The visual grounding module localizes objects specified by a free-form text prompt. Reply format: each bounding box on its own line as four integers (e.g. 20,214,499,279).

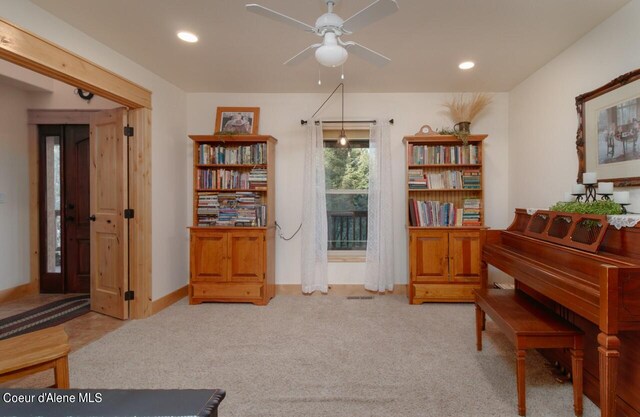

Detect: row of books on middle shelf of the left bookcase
197,168,267,190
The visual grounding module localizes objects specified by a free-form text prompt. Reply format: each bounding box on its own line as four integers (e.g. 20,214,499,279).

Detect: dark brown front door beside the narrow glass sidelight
62,125,91,293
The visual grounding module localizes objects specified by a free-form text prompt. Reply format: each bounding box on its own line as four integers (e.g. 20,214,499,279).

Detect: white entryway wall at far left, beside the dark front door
0,83,29,291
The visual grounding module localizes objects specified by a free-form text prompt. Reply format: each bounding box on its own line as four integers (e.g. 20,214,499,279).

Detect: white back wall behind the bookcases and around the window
182,92,511,284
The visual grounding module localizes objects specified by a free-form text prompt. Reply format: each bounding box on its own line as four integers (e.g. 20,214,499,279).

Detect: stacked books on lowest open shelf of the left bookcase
196,191,267,227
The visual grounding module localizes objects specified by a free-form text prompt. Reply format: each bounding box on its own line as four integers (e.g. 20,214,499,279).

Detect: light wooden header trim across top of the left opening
0,19,151,109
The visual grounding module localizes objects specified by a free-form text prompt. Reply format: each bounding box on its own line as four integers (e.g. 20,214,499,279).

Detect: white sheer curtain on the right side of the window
364,120,395,292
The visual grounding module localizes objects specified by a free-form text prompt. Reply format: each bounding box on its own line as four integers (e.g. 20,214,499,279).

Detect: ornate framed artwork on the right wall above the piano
576,69,640,187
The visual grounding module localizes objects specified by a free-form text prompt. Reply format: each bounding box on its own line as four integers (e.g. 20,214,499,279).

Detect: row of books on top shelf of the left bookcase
198,143,267,165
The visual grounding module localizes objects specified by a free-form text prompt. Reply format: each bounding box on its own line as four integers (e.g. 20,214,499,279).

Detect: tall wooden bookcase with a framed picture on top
189,135,277,305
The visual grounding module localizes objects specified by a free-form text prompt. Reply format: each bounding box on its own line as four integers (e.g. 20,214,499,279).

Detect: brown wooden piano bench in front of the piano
474,289,583,416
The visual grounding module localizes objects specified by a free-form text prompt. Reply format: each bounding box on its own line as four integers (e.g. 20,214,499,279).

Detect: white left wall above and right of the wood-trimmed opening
0,0,189,299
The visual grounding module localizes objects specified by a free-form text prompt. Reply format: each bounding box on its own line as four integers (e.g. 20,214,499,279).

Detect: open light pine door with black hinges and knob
90,108,129,319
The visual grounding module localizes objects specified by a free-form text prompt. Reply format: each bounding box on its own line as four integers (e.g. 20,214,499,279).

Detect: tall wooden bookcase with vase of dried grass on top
403,135,487,304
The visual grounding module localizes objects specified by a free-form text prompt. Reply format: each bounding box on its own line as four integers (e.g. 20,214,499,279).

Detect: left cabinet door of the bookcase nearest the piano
409,230,449,282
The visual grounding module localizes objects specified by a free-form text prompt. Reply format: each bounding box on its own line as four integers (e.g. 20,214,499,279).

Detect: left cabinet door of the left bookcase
190,230,228,282
